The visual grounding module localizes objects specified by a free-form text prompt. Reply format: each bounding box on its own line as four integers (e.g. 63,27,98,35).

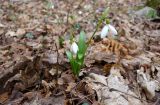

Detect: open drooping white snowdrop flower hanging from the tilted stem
101,24,118,38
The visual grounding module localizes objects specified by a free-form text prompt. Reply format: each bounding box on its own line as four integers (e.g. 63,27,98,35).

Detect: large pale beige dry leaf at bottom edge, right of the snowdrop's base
86,67,143,105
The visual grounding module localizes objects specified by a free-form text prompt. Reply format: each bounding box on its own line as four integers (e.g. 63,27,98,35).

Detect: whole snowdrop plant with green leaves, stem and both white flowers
66,8,118,77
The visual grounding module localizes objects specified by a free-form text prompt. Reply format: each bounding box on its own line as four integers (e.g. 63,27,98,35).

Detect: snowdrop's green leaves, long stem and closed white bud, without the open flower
66,8,109,77
